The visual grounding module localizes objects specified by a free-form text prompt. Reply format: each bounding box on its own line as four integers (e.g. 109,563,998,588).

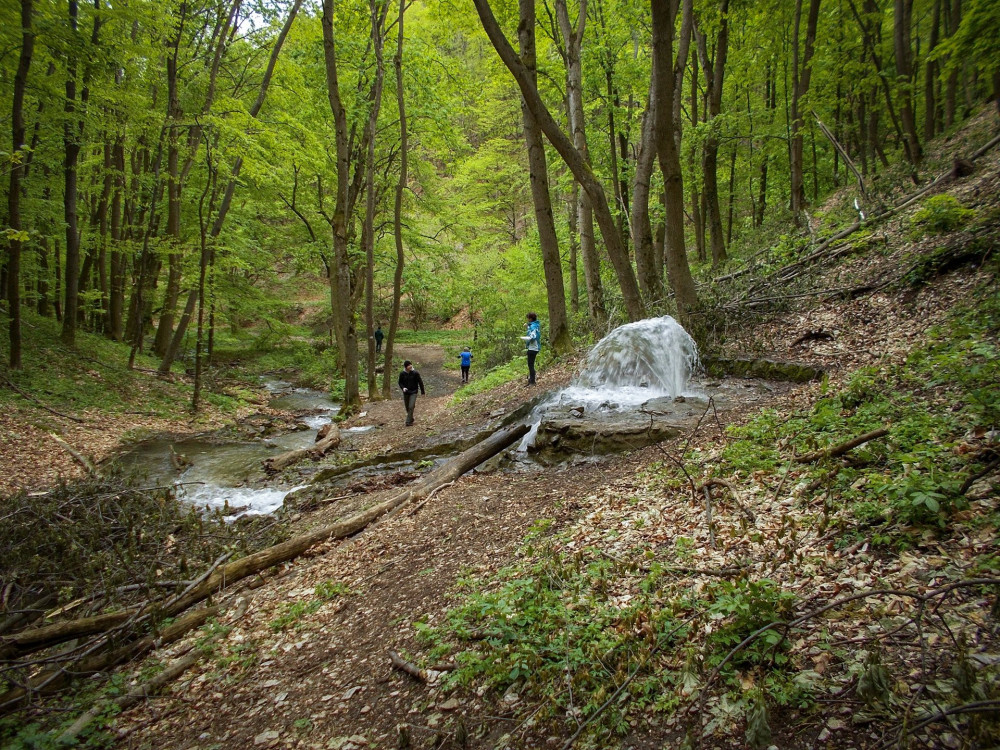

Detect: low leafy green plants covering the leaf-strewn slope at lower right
417,268,1000,747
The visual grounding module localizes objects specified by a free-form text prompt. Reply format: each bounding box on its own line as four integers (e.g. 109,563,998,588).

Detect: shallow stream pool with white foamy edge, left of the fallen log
119,380,340,517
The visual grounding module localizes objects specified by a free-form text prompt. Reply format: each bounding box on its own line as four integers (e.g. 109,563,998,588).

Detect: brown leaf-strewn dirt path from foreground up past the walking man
119,345,584,749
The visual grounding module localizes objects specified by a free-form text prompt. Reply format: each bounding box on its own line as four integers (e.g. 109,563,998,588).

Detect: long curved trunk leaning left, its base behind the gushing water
475,0,644,320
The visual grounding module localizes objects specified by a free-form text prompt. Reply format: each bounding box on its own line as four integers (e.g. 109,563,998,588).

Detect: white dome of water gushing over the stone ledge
518,315,699,451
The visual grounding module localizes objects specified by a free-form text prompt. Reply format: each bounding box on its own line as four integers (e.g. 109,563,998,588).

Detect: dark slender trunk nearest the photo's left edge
7,0,35,370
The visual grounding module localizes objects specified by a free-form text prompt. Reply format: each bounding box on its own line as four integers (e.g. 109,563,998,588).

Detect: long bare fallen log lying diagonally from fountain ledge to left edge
0,424,528,680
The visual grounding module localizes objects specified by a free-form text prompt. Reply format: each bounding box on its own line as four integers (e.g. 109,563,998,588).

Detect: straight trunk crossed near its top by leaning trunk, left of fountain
518,0,573,355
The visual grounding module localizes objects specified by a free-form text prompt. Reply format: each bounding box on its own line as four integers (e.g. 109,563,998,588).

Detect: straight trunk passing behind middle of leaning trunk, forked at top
556,0,608,332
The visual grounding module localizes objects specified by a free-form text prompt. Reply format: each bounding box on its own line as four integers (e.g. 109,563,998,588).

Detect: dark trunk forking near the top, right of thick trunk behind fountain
698,0,729,268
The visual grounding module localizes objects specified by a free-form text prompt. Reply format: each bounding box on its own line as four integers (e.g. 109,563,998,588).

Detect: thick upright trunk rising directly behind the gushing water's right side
652,0,698,323
